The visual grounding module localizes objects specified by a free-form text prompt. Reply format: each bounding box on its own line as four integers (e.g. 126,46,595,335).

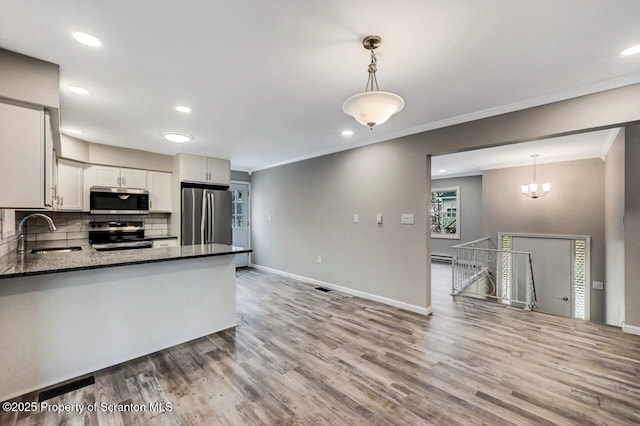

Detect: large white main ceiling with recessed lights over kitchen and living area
0,0,640,170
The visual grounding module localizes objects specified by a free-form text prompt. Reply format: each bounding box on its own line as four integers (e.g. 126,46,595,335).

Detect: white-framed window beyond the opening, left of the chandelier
431,187,460,240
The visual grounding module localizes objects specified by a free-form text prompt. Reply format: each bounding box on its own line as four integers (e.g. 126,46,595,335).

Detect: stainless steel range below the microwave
89,221,153,251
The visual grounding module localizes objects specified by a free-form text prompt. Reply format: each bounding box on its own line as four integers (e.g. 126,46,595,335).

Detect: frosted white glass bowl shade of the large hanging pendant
342,90,404,128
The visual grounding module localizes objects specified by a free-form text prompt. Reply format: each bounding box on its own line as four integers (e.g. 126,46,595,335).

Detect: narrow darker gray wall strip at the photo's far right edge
624,123,640,333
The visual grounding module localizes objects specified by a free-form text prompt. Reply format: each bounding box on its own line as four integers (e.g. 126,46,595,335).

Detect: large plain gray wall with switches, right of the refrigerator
251,143,428,308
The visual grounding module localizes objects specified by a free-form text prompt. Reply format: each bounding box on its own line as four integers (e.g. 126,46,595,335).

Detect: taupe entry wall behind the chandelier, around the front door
482,158,604,322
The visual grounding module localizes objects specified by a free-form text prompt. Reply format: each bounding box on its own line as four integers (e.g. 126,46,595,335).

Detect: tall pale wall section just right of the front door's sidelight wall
604,129,625,326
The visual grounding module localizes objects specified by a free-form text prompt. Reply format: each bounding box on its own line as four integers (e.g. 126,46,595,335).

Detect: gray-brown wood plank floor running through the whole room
0,263,640,425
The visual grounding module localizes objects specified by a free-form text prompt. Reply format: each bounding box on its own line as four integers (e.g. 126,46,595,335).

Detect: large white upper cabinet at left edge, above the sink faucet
0,103,53,209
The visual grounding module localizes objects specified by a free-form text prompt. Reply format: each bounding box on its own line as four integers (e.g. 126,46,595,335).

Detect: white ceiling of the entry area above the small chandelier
431,129,620,179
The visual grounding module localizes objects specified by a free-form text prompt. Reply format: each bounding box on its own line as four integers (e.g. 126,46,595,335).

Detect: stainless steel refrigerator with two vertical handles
182,187,232,246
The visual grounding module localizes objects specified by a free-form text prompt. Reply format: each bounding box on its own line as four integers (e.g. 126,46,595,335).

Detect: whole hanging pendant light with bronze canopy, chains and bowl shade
342,36,404,129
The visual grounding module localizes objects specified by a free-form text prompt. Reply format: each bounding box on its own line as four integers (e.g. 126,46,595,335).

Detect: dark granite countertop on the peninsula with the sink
0,240,253,279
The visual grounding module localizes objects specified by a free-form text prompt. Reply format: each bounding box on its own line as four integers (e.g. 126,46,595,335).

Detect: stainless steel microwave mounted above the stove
89,186,149,214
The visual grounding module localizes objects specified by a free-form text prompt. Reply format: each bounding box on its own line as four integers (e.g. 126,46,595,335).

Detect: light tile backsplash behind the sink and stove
14,211,169,245
